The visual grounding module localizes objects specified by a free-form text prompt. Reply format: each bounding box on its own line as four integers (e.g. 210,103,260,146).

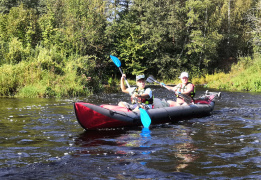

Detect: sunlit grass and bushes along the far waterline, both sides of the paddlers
0,47,261,97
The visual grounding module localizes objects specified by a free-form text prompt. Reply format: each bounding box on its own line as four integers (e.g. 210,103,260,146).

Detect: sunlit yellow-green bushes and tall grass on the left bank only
0,46,102,97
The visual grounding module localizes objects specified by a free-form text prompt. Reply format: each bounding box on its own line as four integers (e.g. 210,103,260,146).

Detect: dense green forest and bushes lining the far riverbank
0,0,261,97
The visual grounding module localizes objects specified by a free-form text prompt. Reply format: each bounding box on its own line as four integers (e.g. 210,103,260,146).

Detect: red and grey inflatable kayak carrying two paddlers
74,92,220,130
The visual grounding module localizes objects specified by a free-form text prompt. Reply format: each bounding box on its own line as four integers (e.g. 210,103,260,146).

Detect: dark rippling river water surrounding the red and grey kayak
0,87,261,180
